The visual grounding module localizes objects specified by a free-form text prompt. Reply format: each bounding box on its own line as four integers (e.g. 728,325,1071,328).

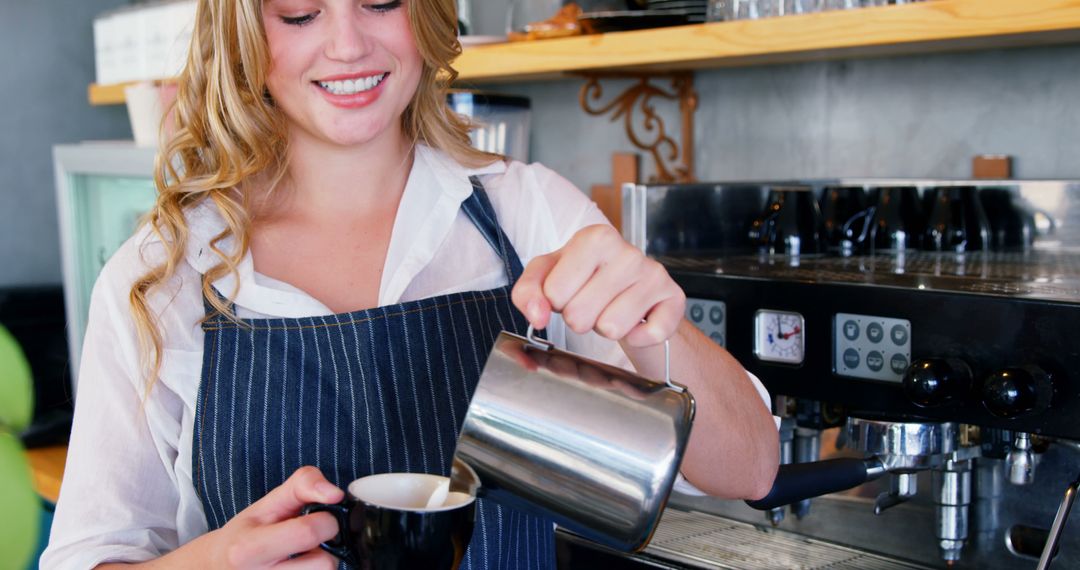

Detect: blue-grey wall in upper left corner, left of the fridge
0,0,131,286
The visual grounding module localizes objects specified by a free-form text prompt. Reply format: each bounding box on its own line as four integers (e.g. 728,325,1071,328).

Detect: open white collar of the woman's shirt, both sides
185,145,507,317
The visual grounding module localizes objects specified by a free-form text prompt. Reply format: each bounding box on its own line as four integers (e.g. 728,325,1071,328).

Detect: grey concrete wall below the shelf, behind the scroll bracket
483,42,1080,190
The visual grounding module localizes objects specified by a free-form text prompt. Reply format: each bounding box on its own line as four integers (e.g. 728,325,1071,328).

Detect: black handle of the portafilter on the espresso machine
746,457,887,511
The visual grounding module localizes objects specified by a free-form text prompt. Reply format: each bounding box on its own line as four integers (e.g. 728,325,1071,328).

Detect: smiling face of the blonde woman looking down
262,0,423,146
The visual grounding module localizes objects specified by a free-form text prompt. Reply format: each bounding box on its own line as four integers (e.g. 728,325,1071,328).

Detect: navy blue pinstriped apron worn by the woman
192,177,555,570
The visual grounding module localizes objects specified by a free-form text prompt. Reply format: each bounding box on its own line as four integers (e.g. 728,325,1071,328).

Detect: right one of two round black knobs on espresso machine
983,366,1054,419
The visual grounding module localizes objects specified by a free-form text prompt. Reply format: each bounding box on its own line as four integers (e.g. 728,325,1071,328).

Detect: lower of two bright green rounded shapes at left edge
0,432,41,569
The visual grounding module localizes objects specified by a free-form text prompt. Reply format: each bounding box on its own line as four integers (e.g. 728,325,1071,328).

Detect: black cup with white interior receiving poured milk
302,473,476,570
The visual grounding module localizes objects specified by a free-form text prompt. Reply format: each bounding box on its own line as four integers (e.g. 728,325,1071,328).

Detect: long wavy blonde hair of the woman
129,0,501,393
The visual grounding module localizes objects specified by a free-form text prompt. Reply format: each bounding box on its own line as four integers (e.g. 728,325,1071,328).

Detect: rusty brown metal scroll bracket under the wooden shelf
580,71,698,184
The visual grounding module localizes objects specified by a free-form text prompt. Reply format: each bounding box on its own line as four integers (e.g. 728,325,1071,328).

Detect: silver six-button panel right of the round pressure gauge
833,313,912,383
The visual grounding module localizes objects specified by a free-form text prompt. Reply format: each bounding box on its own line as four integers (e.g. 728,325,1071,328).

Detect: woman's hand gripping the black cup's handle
98,466,345,570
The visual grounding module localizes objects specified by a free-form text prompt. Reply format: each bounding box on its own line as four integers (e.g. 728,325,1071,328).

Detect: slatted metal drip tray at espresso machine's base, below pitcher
559,508,930,570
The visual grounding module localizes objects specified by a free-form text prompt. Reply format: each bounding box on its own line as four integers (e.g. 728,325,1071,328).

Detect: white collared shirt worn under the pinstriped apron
41,146,768,569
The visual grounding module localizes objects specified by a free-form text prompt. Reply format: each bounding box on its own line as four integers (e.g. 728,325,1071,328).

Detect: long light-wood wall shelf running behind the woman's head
90,0,1080,105
